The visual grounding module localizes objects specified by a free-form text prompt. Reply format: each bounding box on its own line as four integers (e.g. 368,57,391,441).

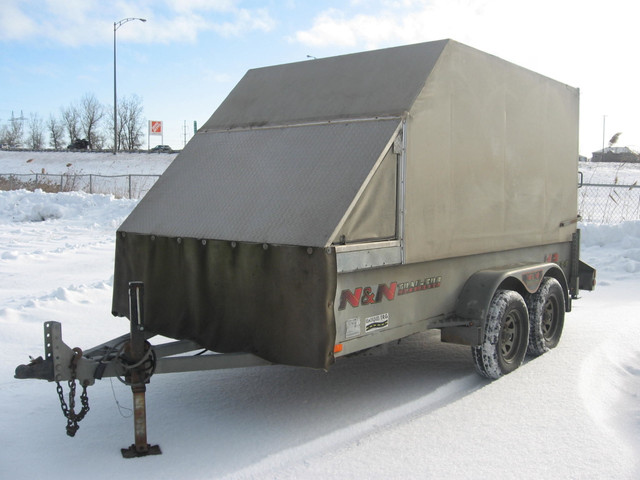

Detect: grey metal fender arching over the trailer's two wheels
442,263,571,345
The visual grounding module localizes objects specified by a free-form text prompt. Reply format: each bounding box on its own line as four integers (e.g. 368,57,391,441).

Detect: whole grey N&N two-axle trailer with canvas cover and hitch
16,40,595,457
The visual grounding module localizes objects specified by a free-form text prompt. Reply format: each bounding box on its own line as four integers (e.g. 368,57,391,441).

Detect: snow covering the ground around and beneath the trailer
0,153,640,479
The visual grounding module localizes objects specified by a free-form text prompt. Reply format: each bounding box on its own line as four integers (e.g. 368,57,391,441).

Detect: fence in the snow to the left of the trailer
0,173,160,198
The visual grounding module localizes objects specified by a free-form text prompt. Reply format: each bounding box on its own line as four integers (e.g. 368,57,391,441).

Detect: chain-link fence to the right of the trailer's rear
578,182,640,223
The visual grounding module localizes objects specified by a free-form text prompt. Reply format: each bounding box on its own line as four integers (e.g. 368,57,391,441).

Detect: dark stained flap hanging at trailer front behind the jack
113,232,336,368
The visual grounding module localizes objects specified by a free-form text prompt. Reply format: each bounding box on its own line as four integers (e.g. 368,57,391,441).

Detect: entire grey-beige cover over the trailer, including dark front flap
113,40,578,368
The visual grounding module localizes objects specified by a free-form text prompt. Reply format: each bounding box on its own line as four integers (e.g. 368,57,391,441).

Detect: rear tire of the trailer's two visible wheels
527,277,565,357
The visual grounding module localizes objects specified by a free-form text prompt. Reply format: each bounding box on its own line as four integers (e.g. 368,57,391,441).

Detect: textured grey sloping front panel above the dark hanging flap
120,119,400,247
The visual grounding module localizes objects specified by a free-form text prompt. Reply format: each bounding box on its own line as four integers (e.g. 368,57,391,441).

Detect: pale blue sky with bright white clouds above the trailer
0,0,640,157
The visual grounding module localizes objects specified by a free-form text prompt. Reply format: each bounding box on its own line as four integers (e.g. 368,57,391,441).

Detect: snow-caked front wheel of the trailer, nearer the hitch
471,290,529,379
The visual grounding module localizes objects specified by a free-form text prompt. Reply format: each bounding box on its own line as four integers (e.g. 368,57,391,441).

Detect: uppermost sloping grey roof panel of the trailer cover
201,40,450,131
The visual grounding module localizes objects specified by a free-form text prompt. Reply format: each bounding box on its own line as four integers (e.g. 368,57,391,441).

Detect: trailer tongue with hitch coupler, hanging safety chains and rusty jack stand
15,282,271,458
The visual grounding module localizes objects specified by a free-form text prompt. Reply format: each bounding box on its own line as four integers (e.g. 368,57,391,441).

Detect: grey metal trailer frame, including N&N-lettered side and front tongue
15,231,595,458
